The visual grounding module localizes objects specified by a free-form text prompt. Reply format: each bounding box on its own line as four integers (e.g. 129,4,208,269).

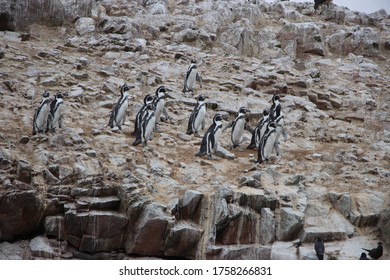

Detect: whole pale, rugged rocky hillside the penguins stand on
0,0,390,259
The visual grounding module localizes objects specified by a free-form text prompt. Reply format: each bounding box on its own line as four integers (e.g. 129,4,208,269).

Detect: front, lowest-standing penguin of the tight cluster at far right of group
256,122,287,163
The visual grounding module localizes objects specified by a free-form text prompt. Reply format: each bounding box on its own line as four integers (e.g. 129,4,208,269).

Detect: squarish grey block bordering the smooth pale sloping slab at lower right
276,208,305,241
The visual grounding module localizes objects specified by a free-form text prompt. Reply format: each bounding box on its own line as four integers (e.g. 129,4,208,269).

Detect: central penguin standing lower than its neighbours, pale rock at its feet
196,114,222,159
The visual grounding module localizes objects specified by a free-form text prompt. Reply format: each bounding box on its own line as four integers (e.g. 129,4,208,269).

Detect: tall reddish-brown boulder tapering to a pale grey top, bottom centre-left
125,203,173,256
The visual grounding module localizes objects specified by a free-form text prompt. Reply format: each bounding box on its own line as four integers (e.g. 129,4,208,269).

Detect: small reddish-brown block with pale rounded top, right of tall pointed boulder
164,221,204,258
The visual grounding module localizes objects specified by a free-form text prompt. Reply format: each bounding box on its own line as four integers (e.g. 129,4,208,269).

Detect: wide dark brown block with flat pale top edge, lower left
65,210,128,253
